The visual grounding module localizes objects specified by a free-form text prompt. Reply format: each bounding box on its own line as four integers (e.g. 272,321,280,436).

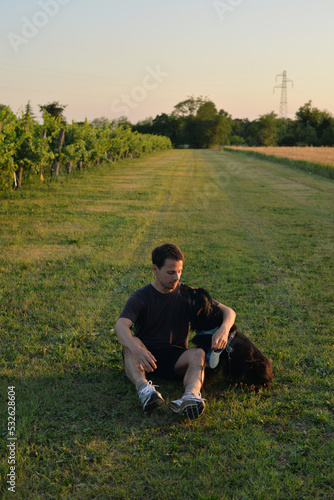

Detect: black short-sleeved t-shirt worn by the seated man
120,284,190,349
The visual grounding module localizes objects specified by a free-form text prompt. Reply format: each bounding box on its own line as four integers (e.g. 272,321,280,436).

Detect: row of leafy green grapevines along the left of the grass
0,102,172,188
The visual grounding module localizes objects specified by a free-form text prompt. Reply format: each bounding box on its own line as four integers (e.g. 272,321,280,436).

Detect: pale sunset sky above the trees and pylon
0,0,334,123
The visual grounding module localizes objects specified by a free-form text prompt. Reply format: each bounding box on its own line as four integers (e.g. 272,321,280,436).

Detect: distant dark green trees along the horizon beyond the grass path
132,97,334,148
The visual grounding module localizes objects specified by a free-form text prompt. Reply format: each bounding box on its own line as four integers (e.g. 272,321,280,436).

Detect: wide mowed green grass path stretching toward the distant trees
0,150,334,500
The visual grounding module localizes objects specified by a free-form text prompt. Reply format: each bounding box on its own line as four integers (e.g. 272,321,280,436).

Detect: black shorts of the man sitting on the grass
147,345,187,380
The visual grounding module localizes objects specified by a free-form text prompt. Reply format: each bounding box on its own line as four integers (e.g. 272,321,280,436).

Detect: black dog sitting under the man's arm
180,284,273,388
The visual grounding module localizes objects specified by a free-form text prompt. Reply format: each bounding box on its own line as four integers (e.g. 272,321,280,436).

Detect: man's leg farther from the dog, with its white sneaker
123,337,164,413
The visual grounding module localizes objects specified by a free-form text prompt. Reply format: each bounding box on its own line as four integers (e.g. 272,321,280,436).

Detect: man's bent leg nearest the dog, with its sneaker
169,349,205,418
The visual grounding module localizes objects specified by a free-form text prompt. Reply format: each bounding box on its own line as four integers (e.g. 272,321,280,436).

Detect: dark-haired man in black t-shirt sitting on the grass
115,243,235,418
